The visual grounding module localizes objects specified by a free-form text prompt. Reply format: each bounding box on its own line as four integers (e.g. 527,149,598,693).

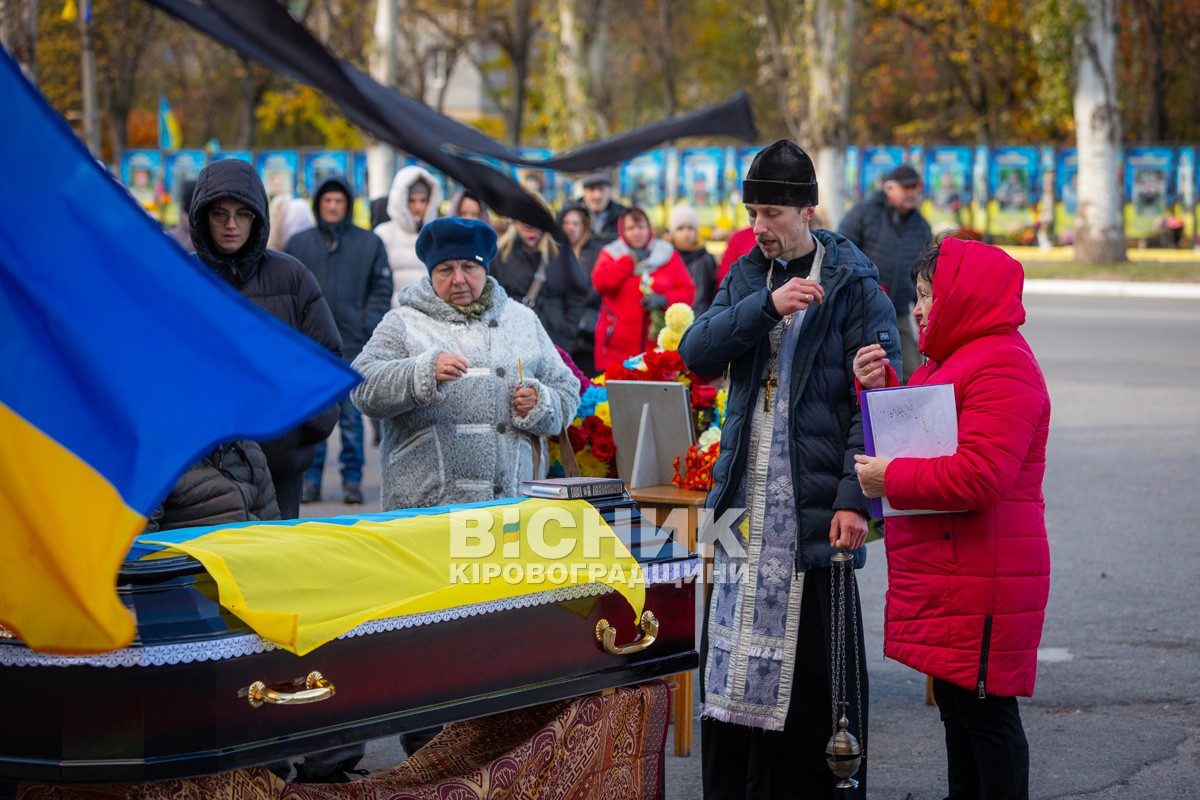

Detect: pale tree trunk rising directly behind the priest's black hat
804,0,856,229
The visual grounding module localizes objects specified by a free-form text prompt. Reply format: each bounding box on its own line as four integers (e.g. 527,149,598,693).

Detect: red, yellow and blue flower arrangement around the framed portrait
550,302,727,489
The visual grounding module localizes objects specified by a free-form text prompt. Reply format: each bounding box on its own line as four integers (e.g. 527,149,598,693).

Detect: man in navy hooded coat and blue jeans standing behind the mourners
284,175,392,505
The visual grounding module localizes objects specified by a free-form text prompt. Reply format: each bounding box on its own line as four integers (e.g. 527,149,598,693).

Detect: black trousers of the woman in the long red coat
934,679,1030,800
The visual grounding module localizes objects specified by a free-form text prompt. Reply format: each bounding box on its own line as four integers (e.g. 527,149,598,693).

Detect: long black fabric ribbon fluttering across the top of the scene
146,0,757,234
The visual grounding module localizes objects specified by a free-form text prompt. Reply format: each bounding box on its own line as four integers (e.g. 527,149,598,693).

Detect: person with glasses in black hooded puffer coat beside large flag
191,160,342,519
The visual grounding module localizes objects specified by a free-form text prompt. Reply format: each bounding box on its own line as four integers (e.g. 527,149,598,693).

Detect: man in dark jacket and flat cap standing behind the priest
838,164,934,383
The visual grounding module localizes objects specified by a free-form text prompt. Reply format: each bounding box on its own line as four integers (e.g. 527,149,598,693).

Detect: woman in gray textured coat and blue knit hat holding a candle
350,217,580,511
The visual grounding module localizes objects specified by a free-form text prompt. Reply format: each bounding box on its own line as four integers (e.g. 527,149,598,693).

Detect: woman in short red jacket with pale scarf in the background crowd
592,207,696,371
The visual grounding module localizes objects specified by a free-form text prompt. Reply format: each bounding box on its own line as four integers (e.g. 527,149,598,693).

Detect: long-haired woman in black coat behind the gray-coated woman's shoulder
490,199,592,350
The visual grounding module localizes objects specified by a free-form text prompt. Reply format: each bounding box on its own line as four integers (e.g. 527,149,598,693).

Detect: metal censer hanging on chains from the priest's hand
826,551,865,789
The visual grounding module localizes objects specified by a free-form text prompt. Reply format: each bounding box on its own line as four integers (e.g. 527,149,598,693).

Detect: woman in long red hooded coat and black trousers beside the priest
854,239,1050,799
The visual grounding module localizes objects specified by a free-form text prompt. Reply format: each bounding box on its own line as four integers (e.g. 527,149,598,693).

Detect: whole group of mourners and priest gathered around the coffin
151,140,1050,800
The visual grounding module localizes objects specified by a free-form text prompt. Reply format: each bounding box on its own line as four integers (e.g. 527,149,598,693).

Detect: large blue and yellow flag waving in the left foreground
0,49,359,652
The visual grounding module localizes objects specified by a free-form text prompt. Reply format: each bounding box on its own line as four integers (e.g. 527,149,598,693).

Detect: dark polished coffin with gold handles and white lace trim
0,494,698,783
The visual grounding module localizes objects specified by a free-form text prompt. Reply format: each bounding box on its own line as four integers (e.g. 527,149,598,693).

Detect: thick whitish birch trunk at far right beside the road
1075,0,1127,264
